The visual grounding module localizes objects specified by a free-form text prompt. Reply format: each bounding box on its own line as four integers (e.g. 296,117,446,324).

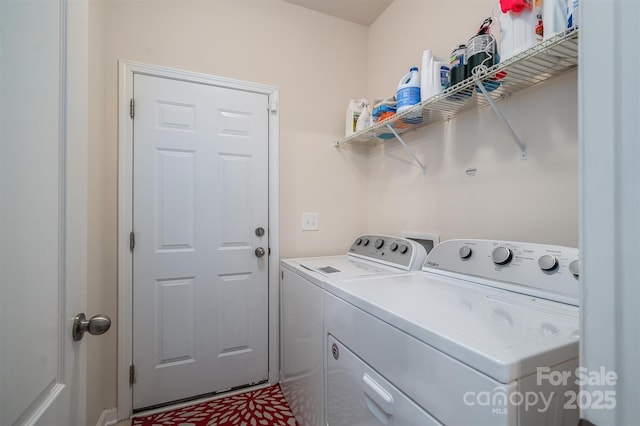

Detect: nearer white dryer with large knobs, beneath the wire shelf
324,240,579,426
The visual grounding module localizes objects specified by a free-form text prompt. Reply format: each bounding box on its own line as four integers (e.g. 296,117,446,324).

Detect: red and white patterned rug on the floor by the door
131,385,297,426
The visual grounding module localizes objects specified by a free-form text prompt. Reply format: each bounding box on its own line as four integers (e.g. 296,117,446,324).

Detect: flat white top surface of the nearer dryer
325,273,579,383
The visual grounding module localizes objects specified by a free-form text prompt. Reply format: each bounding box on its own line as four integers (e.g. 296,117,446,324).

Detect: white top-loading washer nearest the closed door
280,235,426,426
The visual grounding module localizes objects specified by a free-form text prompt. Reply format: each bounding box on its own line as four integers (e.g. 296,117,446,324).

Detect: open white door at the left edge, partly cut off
0,0,87,426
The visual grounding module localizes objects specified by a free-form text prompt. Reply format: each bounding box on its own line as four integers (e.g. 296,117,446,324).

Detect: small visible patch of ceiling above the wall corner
284,0,393,27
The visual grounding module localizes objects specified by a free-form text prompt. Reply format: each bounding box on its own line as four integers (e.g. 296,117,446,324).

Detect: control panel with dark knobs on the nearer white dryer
423,240,580,306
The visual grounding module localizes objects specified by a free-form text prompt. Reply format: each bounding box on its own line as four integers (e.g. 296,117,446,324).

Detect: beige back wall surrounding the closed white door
88,0,368,424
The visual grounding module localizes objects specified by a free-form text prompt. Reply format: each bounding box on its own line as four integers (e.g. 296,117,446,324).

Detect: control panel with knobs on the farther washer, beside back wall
348,234,427,271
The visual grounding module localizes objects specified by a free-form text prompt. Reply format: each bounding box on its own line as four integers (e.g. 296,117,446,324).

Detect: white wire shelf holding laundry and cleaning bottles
334,27,578,146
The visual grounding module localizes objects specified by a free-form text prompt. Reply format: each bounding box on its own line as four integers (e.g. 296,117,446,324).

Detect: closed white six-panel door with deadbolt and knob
133,74,268,410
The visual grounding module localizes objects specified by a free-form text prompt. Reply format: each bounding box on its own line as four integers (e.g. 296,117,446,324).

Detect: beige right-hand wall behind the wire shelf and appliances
368,0,578,247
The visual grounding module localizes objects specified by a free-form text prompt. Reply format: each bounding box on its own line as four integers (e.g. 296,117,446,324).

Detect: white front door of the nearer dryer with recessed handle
327,335,441,426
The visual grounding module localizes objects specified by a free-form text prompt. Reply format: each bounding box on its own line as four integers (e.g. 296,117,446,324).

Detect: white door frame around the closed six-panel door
117,60,280,420
